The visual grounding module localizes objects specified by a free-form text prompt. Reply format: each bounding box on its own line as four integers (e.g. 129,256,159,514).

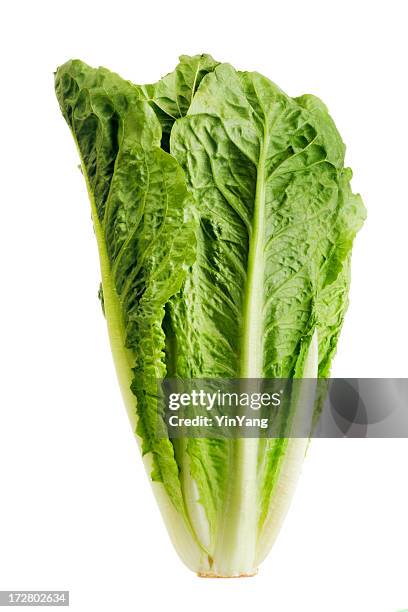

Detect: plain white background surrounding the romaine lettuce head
0,0,408,612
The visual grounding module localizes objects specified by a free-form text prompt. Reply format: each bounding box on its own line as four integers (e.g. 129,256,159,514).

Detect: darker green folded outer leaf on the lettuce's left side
56,61,194,514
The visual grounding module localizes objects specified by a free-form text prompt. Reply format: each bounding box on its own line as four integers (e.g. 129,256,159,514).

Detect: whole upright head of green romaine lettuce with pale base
55,55,365,576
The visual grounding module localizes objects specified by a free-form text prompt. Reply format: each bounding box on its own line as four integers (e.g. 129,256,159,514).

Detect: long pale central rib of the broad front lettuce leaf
206,136,268,576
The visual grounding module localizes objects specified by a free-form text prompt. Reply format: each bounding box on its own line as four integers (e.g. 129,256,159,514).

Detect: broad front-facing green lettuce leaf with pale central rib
170,65,364,573
